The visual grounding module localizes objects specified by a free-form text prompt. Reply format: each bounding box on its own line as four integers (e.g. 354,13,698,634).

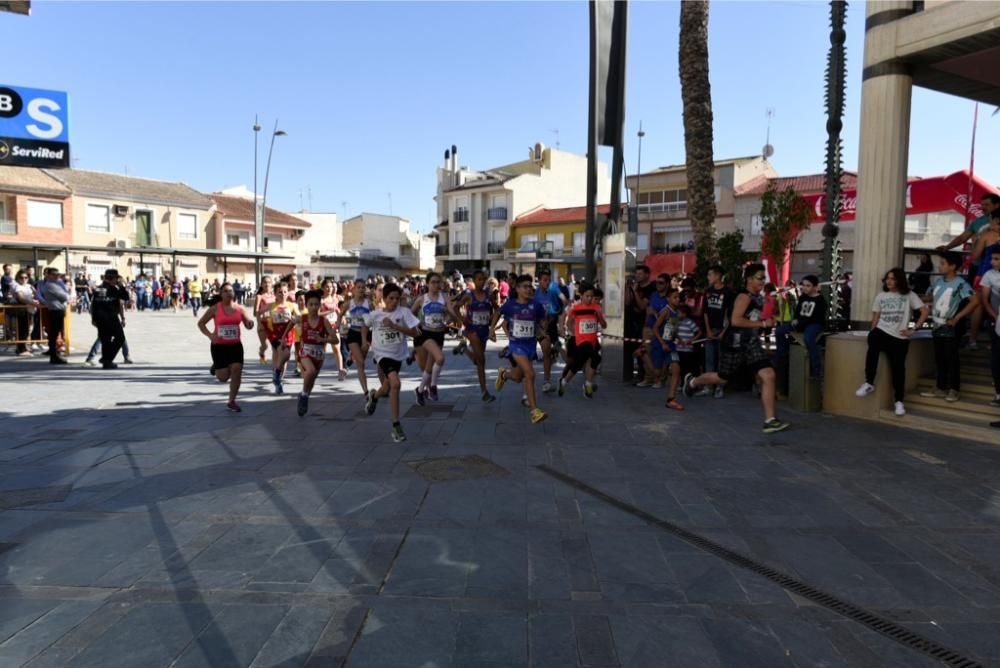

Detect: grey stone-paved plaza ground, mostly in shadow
0,312,1000,668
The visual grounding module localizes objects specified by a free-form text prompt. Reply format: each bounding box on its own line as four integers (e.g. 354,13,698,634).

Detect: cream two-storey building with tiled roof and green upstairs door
44,169,213,278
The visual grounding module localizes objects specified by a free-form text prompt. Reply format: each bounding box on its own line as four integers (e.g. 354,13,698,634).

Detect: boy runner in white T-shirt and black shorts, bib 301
361,284,420,443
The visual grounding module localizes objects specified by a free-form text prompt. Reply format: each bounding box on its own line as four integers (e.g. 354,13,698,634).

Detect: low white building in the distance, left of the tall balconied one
341,213,434,273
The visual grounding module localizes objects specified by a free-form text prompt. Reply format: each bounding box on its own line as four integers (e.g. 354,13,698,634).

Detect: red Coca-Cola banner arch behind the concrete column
802,170,997,223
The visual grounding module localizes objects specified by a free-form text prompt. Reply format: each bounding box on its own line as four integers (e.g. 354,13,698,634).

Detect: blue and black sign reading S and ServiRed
0,84,69,167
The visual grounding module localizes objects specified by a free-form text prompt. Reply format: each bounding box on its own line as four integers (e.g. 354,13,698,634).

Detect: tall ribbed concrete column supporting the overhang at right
851,0,913,327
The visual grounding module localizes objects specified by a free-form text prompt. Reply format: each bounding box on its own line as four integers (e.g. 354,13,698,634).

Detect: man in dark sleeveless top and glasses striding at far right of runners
684,263,788,434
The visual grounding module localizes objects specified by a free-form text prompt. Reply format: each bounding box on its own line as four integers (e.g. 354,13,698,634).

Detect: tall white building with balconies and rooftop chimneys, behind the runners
435,144,611,274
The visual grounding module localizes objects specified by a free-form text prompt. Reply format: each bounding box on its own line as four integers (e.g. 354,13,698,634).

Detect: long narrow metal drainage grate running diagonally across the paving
536,464,983,668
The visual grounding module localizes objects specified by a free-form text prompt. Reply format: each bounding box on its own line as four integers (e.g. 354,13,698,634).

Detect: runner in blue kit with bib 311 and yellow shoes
490,274,548,423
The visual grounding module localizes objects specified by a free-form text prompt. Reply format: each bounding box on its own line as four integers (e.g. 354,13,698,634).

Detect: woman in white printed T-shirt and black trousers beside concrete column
855,267,929,417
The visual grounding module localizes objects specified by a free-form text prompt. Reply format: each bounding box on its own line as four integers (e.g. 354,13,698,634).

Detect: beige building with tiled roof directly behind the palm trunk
625,156,777,262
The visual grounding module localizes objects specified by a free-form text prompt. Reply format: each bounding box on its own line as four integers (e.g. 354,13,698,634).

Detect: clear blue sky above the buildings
0,0,1000,230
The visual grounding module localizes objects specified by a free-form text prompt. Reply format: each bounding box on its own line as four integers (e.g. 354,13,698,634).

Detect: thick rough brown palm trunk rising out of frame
678,0,718,274
